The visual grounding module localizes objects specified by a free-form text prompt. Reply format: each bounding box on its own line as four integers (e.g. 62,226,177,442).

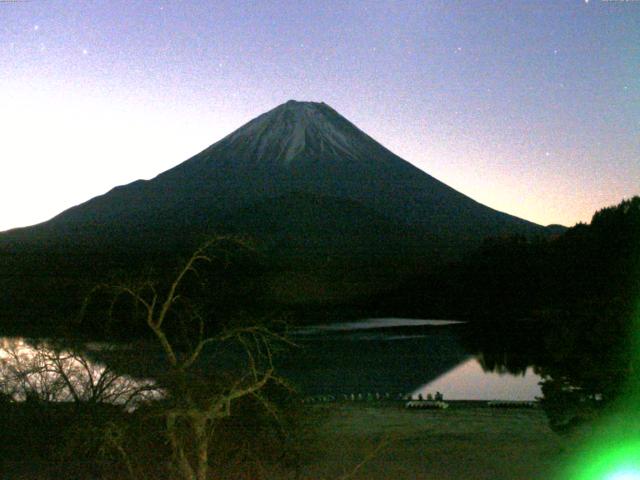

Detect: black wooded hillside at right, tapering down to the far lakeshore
388,196,640,321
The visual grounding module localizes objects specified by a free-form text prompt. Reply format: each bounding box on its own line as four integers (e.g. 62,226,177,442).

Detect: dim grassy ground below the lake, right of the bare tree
301,404,576,480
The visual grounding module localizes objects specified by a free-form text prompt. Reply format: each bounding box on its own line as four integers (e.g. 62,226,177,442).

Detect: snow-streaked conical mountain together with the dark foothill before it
0,100,545,259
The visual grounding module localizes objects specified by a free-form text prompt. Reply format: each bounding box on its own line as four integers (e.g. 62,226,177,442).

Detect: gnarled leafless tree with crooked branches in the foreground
85,237,289,480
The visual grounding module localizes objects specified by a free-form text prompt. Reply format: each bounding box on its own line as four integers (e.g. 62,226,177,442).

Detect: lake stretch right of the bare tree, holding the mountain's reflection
282,318,542,401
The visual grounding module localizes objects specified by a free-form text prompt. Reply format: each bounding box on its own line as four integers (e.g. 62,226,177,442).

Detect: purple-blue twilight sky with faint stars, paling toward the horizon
0,0,640,230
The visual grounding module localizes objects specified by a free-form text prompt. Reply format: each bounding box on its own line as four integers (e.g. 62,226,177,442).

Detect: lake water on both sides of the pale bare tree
0,318,540,403
